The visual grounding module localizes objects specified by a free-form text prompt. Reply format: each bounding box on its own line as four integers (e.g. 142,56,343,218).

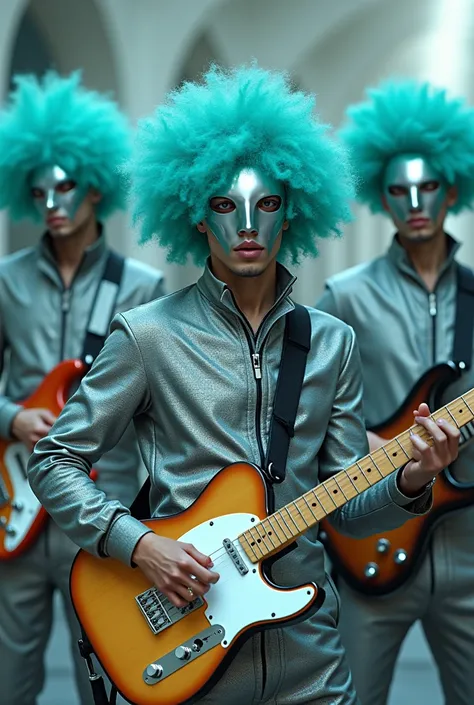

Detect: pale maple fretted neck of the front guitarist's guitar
238,389,474,563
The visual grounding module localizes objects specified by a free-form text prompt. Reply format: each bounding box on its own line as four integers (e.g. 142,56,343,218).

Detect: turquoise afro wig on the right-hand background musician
339,80,474,213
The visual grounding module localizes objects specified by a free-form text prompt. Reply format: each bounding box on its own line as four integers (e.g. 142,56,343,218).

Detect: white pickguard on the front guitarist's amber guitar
180,514,316,648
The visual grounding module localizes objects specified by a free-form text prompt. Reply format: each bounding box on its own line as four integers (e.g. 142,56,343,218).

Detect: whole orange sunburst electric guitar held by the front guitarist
71,390,474,705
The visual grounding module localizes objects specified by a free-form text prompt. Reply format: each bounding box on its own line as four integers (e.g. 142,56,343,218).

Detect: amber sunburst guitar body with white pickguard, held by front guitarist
71,463,324,705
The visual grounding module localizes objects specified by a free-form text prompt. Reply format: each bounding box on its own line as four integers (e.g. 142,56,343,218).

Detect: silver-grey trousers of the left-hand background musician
0,520,93,705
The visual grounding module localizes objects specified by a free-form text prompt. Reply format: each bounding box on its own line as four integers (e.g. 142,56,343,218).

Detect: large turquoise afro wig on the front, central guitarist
131,65,353,264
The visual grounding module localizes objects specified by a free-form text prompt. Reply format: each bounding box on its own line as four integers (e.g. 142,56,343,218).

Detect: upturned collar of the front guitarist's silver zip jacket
197,258,296,337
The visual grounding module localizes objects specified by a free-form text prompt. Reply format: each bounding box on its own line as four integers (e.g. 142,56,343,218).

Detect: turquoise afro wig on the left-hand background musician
0,72,131,220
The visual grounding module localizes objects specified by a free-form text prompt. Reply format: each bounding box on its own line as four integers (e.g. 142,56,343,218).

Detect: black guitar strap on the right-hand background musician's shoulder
452,264,474,370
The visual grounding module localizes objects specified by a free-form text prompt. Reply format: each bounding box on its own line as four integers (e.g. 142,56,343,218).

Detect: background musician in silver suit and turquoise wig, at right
316,81,474,705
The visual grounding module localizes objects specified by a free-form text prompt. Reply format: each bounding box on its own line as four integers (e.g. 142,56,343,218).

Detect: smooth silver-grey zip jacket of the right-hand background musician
316,236,474,545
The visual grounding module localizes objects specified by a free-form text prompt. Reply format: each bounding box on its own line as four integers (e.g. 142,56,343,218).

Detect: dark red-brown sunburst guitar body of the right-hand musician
321,364,474,595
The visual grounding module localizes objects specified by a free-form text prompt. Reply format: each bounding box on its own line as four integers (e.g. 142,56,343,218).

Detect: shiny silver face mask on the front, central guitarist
206,169,285,254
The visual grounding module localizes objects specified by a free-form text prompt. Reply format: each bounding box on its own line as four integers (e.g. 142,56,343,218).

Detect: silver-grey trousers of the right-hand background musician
339,523,474,705
